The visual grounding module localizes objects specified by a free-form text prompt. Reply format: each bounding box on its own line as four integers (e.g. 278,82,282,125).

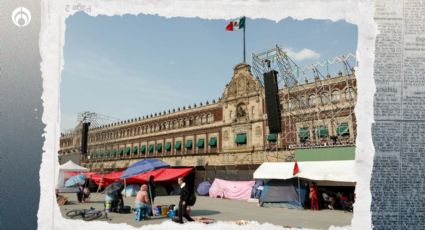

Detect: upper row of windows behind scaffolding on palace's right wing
288,87,355,109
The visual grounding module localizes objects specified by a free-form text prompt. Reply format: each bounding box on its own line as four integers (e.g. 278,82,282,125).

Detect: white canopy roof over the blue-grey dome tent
254,160,356,183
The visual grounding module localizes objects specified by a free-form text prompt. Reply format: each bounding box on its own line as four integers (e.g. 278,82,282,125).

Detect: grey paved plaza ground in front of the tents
60,193,353,229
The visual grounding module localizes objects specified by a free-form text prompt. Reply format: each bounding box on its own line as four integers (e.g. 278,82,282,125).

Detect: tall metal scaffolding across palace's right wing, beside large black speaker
252,45,357,148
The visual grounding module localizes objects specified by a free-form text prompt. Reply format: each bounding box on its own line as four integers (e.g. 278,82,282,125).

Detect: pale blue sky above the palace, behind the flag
60,13,357,131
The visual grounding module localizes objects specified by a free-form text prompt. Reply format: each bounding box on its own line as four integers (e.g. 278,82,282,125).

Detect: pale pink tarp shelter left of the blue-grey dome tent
209,179,255,200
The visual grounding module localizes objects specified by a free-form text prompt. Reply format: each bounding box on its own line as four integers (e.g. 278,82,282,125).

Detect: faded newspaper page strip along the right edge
371,0,425,229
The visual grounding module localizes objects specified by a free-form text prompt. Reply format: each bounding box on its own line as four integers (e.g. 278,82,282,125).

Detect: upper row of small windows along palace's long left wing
89,113,214,142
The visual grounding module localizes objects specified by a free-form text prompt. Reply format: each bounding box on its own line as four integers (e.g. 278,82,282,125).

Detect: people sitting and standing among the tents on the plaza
57,173,355,223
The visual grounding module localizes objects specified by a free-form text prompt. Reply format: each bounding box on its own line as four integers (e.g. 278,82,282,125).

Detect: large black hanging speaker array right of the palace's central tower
263,70,282,133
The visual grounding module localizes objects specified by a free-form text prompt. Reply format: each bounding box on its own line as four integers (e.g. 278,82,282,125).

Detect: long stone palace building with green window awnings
59,64,357,179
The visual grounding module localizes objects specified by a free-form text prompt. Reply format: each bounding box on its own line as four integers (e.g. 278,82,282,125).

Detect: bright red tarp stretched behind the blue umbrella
66,168,192,187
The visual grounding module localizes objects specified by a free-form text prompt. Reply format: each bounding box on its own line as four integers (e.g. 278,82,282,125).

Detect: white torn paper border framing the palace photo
38,0,377,230
